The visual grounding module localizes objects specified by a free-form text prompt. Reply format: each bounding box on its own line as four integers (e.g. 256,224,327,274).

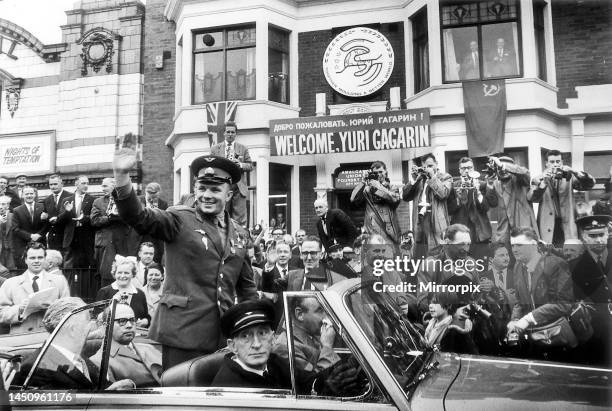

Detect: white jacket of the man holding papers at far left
0,273,70,334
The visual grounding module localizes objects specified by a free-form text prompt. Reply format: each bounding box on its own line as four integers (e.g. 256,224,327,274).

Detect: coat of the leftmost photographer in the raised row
351,183,402,245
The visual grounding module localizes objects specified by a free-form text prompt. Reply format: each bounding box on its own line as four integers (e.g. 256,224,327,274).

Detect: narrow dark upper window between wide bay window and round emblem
268,27,289,104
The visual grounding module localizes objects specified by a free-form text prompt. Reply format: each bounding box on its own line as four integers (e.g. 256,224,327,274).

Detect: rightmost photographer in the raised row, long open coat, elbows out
527,150,595,247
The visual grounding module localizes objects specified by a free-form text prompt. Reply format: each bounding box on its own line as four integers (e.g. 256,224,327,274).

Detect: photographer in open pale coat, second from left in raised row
402,154,453,257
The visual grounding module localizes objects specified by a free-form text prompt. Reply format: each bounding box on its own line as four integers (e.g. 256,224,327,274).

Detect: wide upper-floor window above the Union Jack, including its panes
193,26,255,104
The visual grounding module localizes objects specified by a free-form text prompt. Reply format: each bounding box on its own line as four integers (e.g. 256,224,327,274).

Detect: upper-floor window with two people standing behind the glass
440,0,521,82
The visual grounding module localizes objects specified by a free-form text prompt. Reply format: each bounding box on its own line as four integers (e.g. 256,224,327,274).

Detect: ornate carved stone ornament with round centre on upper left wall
77,27,116,76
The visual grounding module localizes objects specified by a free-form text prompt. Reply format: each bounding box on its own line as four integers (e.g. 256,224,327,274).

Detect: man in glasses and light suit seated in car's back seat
91,304,162,388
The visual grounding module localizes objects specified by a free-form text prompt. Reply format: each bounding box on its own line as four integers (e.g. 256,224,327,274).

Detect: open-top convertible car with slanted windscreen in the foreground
0,279,612,411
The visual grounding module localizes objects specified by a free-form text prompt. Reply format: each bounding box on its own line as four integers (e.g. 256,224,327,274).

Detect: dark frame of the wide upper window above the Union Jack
191,21,257,106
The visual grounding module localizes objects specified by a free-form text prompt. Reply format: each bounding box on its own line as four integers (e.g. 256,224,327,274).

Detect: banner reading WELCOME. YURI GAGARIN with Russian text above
270,108,431,156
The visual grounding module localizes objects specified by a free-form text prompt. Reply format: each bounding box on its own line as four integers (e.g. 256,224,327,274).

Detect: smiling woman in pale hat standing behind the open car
96,255,151,327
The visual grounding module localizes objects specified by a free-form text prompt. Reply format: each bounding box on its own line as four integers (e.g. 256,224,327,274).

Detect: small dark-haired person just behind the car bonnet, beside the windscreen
425,292,478,354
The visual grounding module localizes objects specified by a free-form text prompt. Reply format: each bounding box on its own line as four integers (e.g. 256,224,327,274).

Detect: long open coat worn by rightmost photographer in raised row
527,172,595,244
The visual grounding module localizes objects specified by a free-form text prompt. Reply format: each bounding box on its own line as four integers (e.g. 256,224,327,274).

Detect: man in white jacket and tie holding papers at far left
0,243,70,334
